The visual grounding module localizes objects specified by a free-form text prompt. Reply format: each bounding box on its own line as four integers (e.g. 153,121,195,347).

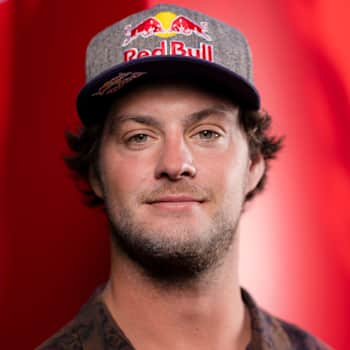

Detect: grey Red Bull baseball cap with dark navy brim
77,4,260,125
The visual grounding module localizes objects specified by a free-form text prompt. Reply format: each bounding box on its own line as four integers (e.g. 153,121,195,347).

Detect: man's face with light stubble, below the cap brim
92,80,263,281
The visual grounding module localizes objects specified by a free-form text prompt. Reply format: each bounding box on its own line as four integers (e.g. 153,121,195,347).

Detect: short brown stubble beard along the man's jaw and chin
106,200,240,287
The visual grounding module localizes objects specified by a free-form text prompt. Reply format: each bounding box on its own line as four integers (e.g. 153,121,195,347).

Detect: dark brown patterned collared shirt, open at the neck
36,289,330,350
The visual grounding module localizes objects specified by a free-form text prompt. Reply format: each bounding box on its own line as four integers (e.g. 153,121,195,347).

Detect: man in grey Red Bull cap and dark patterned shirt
39,5,327,350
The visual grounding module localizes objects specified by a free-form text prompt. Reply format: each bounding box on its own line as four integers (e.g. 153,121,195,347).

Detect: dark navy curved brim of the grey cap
77,56,260,125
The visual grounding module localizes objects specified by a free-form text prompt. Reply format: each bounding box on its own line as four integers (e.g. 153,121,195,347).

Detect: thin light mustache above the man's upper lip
138,182,214,203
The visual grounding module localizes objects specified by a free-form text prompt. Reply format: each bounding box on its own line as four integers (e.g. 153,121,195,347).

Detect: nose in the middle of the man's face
155,138,196,181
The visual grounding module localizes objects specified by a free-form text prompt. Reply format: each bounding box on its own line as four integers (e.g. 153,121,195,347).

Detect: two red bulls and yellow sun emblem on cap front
122,11,212,47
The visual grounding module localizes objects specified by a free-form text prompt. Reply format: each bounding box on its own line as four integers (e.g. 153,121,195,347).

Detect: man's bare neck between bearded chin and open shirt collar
102,237,250,350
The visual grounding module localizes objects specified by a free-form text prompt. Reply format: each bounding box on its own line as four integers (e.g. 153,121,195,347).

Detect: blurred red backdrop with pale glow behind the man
0,0,350,349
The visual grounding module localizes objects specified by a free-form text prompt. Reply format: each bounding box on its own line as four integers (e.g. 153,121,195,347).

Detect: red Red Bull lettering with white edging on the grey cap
124,40,213,62
